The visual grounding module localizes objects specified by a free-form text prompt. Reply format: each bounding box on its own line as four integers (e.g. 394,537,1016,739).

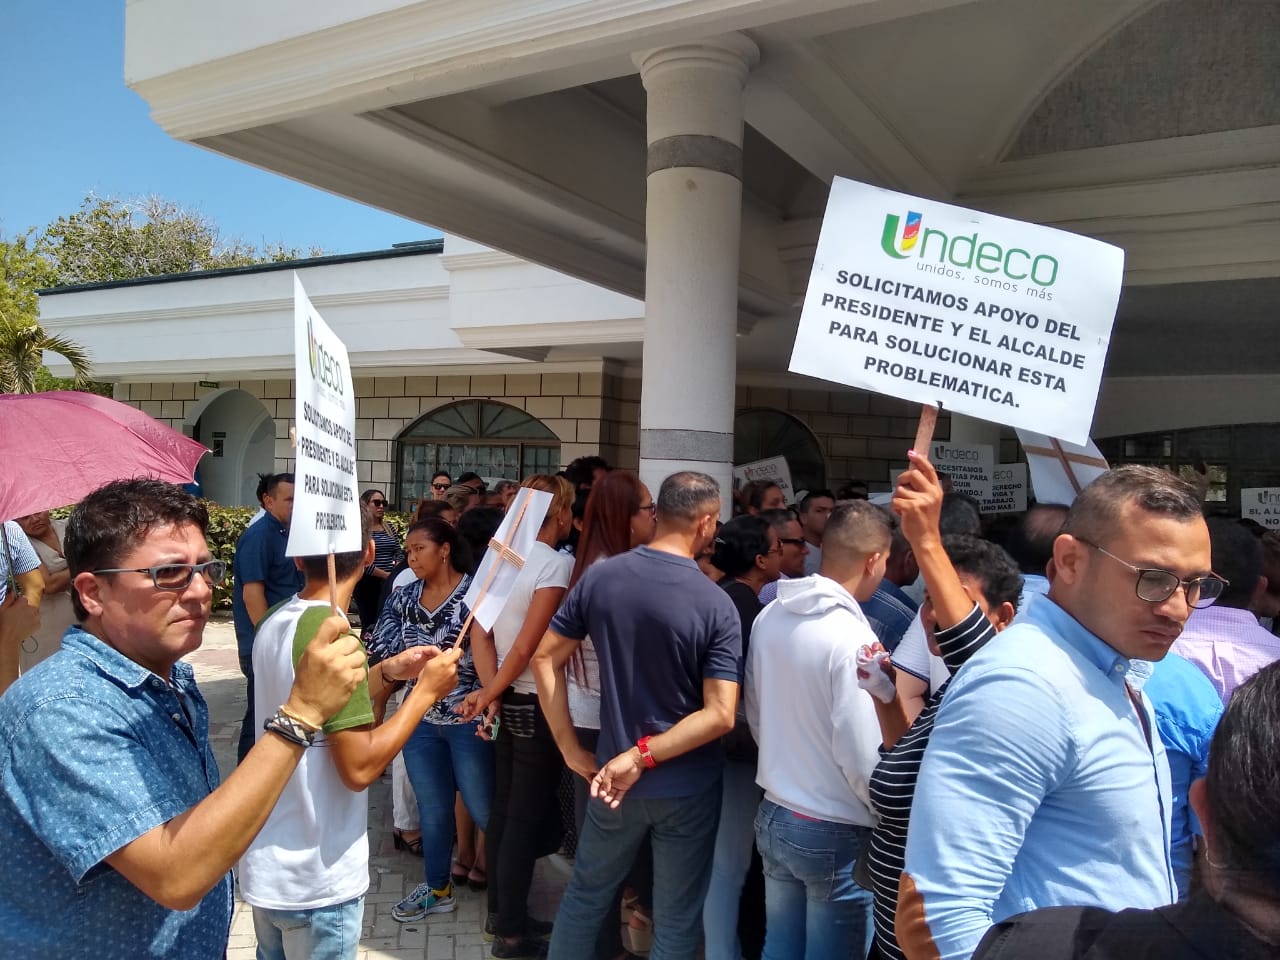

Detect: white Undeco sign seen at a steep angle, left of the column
284,274,364,557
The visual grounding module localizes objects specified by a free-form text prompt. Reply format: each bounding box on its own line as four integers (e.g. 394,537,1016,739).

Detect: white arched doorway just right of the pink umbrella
184,389,275,507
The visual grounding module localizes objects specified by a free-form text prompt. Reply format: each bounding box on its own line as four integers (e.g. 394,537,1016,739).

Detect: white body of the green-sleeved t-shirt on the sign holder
239,596,372,910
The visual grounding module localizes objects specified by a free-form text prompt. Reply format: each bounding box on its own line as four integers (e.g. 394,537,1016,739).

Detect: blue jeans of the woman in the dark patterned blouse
403,722,493,890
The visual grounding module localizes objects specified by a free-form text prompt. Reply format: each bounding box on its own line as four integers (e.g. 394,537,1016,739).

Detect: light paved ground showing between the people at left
187,617,568,960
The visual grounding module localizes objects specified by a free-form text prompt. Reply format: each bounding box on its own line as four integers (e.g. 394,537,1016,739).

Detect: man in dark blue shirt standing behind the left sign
232,474,302,760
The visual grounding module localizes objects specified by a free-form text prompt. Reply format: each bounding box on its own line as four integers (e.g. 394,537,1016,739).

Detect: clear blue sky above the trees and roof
0,0,439,253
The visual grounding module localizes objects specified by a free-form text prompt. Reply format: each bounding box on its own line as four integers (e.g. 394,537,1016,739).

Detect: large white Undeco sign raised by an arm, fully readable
790,177,1124,443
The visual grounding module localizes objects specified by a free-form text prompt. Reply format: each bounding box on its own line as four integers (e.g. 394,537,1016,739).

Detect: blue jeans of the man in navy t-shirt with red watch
548,778,721,960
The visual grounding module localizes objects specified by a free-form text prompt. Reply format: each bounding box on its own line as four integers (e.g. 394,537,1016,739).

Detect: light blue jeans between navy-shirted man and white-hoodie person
703,760,764,960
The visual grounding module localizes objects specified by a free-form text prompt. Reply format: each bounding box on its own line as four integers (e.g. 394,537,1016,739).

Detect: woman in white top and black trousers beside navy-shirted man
458,474,573,957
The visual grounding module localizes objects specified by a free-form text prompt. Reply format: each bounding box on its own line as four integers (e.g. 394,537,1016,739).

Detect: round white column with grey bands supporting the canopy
635,35,759,517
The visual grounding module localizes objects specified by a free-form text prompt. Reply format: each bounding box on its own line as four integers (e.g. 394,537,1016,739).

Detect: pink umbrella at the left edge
0,390,207,520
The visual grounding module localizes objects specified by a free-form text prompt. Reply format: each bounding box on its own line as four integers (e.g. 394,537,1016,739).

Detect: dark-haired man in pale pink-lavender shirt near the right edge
1174,517,1280,704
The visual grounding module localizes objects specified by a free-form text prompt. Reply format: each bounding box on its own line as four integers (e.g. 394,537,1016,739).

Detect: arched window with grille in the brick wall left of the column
396,399,559,509
